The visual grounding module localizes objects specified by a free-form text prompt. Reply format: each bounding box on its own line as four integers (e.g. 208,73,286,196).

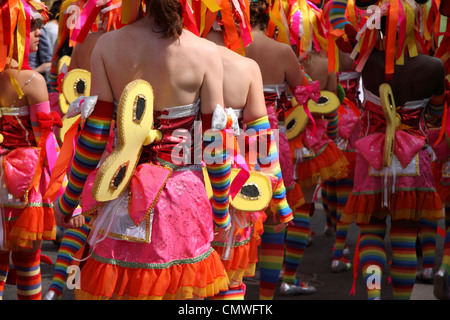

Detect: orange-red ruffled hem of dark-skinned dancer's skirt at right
340,190,443,224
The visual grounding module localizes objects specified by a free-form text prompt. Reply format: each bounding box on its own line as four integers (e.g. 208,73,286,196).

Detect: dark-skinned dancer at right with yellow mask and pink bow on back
330,1,445,299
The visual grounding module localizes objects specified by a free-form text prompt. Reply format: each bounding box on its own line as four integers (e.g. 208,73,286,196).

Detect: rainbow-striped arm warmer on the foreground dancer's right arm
202,115,231,228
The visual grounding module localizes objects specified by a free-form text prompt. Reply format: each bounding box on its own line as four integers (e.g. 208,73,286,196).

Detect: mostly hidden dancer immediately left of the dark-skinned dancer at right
321,2,361,272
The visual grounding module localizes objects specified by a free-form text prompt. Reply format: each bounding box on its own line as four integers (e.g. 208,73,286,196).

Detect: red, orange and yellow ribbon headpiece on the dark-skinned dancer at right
329,0,430,78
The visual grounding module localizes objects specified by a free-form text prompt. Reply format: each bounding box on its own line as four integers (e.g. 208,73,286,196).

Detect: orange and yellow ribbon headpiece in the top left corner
0,0,48,98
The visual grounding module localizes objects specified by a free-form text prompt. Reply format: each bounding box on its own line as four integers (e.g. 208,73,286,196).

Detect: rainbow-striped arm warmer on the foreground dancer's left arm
58,100,114,216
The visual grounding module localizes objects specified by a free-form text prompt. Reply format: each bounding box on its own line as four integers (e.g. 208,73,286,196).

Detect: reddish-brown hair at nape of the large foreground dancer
145,0,183,39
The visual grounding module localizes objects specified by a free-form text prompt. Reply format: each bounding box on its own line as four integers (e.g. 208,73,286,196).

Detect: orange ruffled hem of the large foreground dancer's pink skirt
75,250,229,300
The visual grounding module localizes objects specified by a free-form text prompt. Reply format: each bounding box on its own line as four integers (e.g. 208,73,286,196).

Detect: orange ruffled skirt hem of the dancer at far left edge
7,207,56,249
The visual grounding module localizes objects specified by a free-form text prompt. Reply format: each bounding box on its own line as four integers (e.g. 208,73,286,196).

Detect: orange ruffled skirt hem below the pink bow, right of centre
296,143,349,187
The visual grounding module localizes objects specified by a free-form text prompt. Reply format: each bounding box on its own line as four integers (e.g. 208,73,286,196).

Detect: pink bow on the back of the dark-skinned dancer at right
355,130,425,170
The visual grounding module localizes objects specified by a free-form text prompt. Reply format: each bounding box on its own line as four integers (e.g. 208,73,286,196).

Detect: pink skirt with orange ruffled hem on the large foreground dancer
75,170,229,300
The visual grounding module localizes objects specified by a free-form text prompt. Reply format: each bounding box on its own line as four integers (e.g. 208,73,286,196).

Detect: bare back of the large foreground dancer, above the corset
91,18,223,112
